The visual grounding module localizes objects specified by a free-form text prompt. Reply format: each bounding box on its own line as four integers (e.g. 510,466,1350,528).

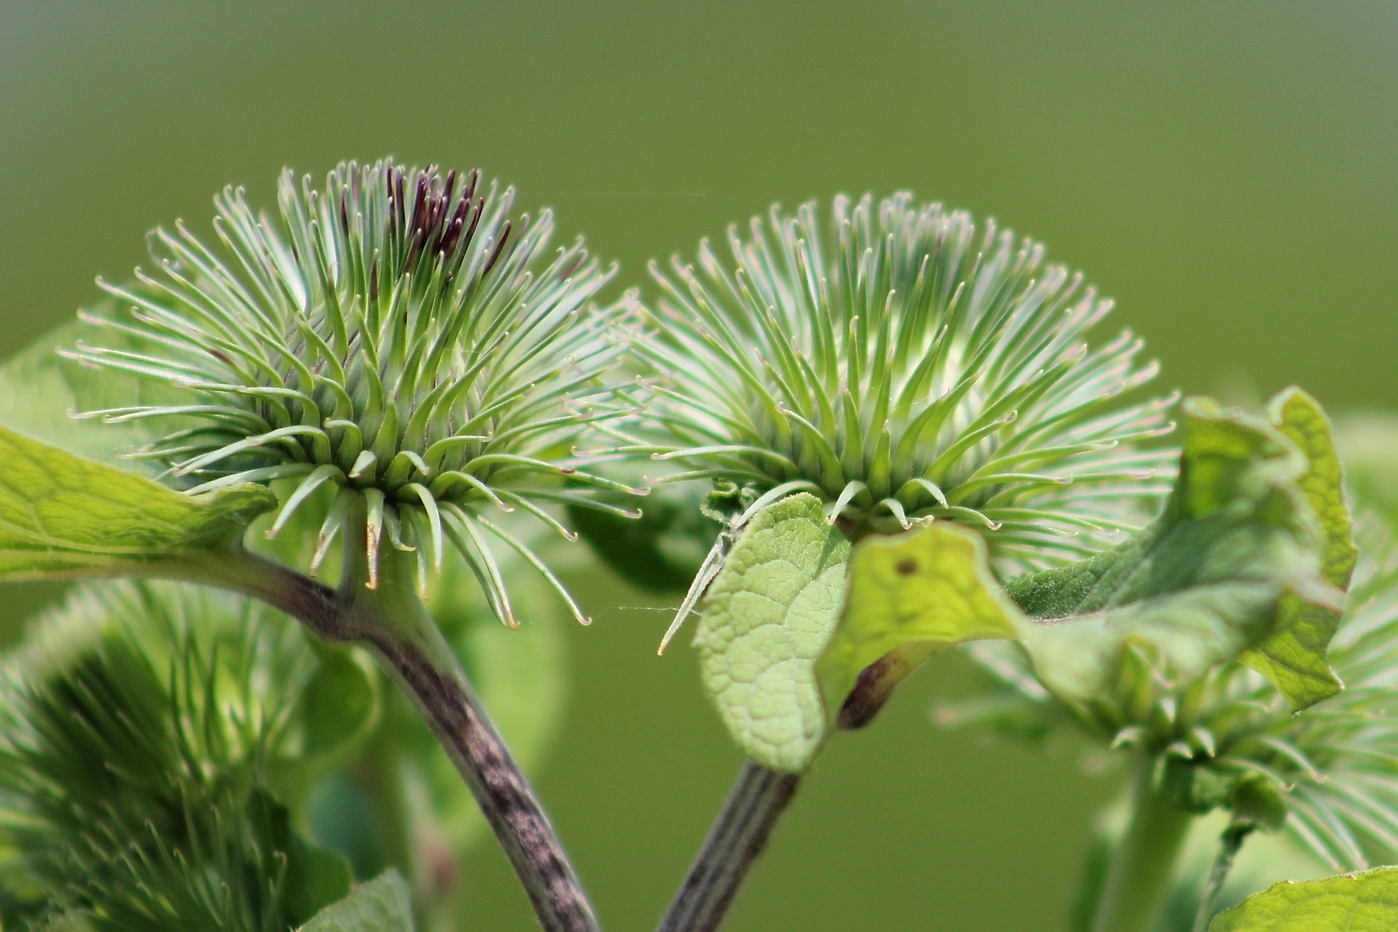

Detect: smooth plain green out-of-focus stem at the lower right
1092,760,1192,932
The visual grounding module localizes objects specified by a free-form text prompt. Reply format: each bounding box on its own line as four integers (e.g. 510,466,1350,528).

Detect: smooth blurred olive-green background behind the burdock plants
0,0,1398,932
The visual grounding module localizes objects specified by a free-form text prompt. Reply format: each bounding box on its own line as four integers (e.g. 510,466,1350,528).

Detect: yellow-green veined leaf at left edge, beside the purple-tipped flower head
0,428,277,580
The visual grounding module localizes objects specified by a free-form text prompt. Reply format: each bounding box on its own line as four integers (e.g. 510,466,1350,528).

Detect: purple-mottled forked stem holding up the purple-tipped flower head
176,547,600,932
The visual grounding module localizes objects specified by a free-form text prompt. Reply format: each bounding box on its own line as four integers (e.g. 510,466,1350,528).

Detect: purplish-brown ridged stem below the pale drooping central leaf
658,760,801,932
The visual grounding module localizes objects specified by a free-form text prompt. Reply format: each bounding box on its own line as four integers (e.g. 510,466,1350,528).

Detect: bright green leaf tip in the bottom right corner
1209,868,1398,932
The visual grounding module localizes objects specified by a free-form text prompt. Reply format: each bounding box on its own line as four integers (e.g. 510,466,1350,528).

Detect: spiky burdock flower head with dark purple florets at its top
70,159,634,620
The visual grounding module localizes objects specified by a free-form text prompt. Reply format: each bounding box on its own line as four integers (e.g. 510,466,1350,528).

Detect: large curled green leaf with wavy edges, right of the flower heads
1008,395,1341,708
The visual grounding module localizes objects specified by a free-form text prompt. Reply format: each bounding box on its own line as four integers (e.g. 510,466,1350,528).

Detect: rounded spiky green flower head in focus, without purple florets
636,193,1173,567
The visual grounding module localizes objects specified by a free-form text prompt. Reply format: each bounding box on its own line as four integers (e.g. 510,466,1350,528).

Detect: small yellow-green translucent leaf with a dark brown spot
816,521,1025,725
